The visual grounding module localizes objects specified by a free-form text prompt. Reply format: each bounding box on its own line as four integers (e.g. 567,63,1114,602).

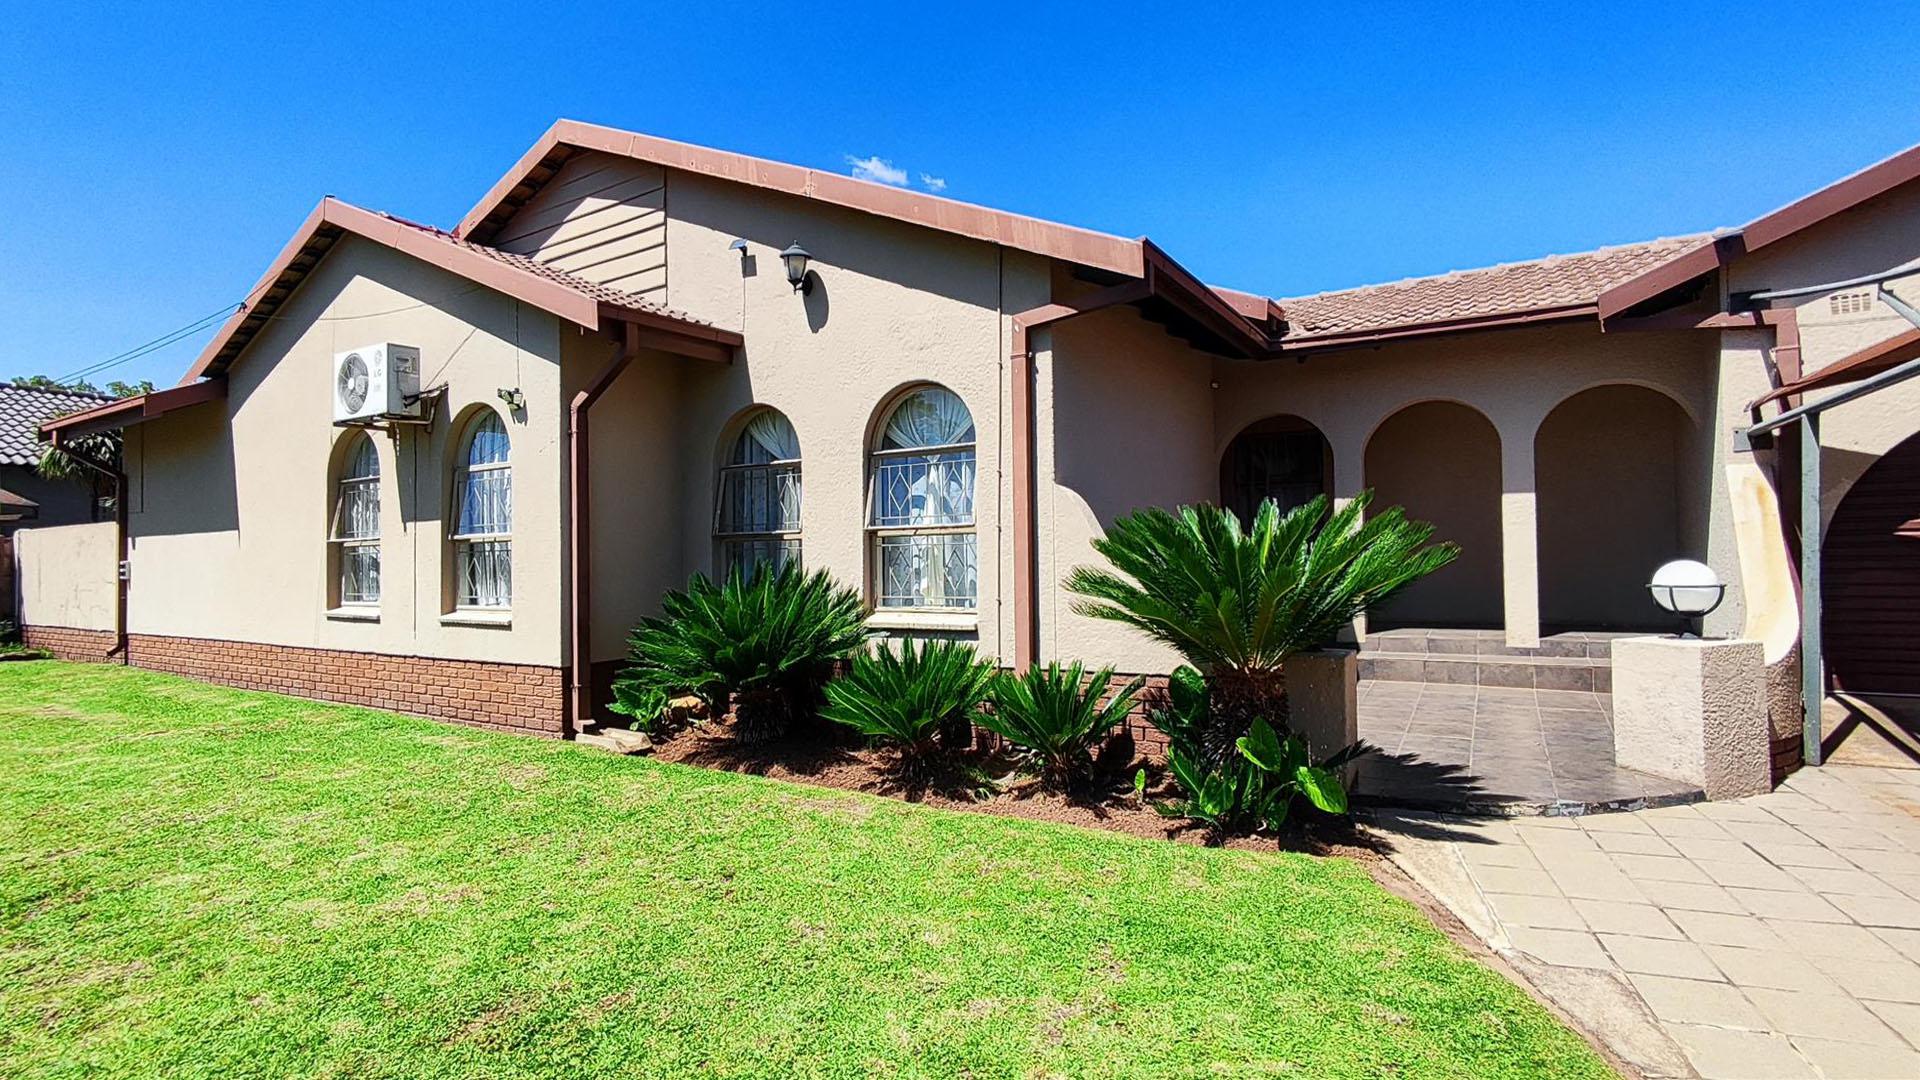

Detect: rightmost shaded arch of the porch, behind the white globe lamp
1534,379,1707,630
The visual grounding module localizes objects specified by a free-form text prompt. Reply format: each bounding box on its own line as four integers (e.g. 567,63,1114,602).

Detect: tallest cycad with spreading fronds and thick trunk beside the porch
1068,492,1459,748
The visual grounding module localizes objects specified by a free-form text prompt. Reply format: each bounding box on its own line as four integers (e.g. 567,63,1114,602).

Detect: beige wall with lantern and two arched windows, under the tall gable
541,171,1048,659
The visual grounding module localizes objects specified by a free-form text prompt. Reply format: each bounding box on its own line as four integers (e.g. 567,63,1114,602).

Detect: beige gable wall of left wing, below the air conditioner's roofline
127,236,564,665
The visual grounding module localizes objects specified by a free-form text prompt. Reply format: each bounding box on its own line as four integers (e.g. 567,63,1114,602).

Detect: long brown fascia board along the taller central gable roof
455,119,1144,277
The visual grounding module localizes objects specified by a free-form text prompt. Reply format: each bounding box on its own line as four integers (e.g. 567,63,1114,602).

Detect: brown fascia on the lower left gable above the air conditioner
180,196,741,384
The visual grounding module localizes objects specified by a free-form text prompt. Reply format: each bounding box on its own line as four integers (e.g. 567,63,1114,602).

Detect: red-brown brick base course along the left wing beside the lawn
23,626,566,736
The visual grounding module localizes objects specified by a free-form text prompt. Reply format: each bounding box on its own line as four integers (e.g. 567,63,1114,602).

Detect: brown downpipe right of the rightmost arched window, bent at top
1010,281,1152,671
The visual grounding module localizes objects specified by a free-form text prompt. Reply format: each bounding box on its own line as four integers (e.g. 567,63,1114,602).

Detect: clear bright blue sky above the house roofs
0,0,1920,384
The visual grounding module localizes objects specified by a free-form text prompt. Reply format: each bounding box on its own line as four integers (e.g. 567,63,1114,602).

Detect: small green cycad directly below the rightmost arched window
820,638,995,773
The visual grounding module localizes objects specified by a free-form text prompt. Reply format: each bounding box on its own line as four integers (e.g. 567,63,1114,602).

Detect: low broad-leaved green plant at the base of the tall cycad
1154,719,1373,844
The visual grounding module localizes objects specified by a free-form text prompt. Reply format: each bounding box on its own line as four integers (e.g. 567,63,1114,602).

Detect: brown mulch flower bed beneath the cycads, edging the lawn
653,719,1382,863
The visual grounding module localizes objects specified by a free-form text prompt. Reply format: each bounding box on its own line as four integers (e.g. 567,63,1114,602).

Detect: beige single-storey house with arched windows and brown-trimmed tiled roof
23,121,1920,768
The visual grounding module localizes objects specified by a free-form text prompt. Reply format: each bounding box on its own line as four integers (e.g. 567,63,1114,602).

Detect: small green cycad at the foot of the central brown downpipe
979,661,1146,792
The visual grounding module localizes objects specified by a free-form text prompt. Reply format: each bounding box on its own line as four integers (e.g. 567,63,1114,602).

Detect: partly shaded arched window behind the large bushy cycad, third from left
714,409,801,575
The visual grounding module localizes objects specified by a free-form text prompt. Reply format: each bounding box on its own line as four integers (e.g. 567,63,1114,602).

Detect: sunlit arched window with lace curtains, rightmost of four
868,386,979,611
